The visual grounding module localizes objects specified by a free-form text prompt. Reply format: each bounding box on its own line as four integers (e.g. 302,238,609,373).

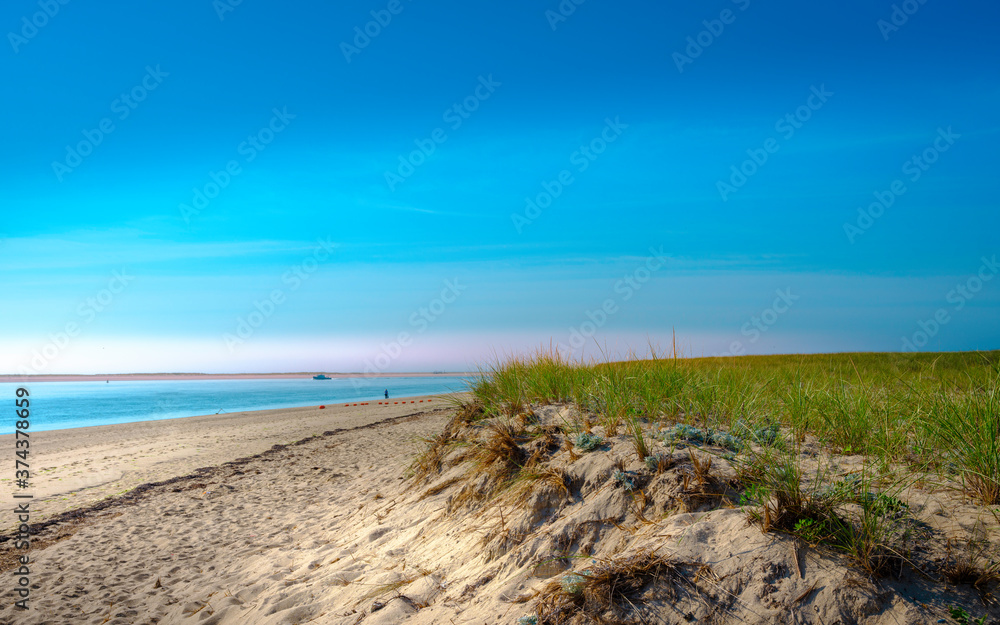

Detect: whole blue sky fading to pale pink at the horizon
0,0,1000,373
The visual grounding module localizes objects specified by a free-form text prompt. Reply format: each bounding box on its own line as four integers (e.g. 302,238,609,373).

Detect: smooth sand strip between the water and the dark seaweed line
0,397,454,530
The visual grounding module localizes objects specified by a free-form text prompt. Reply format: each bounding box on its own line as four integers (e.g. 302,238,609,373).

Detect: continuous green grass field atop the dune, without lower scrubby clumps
471,351,1000,505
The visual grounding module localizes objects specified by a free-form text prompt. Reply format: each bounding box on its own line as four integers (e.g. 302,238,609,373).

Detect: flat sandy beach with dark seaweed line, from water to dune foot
0,397,460,624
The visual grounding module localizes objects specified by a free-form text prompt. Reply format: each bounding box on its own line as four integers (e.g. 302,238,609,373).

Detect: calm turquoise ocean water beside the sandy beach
0,376,468,434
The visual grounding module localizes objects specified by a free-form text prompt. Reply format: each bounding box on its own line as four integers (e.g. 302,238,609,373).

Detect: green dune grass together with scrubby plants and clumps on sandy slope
456,351,1000,584
